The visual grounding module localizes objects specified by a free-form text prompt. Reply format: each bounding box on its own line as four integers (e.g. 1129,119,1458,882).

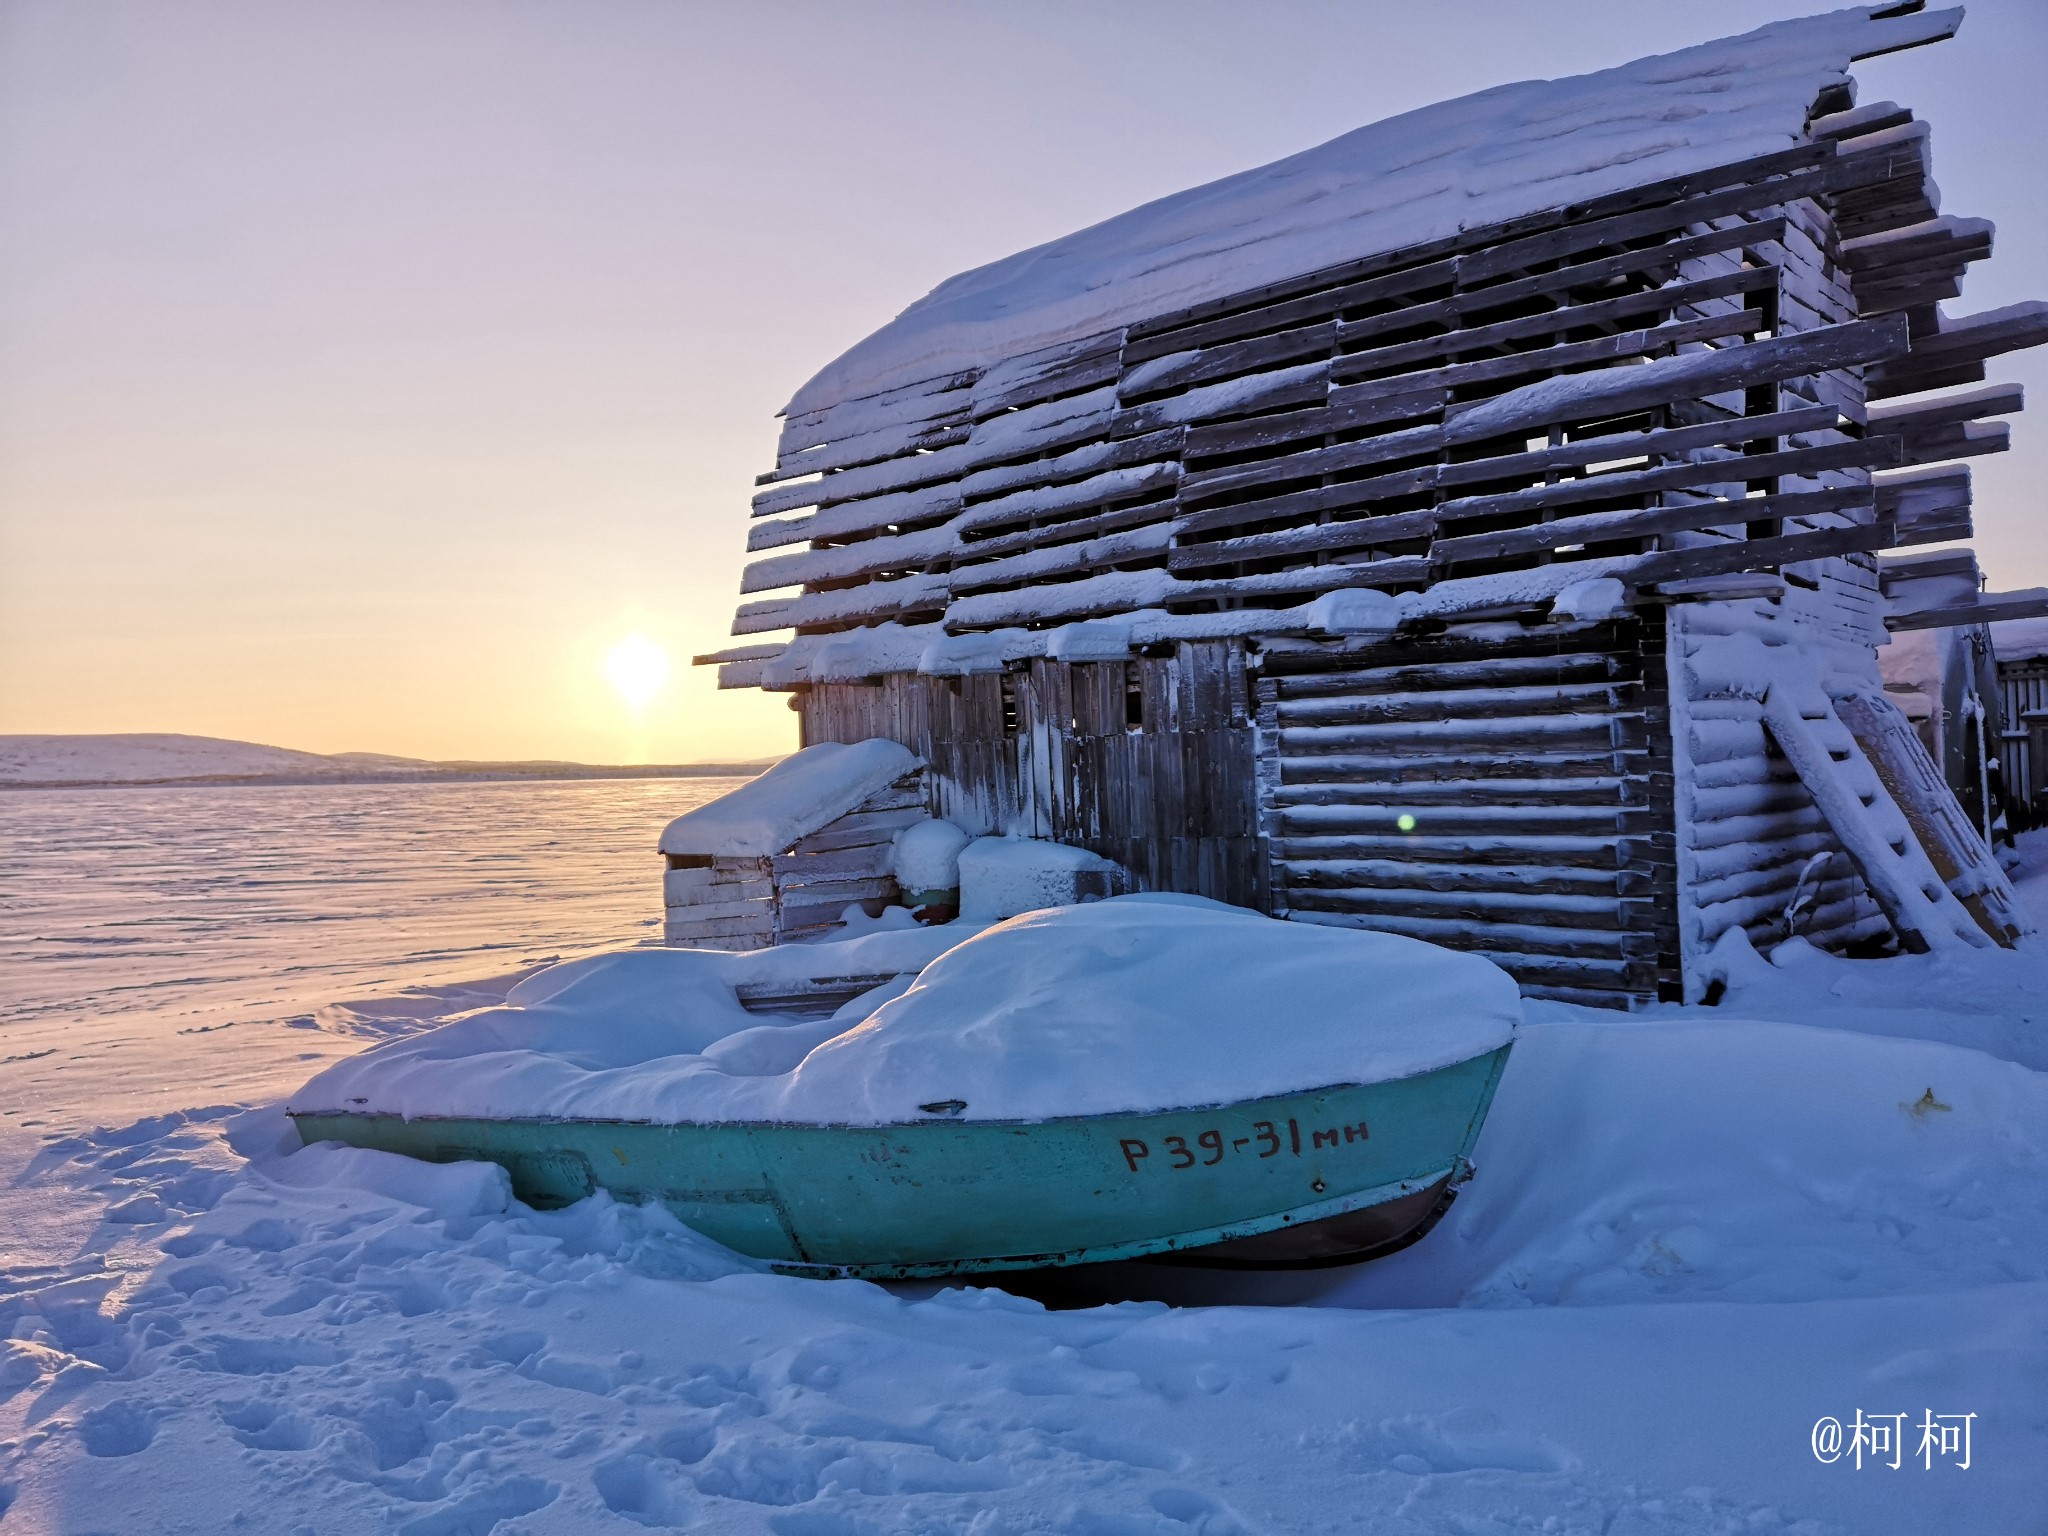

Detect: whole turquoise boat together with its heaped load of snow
291,895,1520,1278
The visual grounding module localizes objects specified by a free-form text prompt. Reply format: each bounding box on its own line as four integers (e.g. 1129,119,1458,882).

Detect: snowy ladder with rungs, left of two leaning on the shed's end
1763,676,1991,954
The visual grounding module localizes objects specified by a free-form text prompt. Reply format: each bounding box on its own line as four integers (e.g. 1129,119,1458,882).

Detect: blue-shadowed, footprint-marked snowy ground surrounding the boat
0,798,2048,1536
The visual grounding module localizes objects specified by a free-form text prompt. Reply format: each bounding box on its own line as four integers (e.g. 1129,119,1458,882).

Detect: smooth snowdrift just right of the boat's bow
1325,1024,2048,1307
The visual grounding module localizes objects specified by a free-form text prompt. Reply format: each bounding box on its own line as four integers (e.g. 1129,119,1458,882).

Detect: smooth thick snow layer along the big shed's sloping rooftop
784,4,1962,418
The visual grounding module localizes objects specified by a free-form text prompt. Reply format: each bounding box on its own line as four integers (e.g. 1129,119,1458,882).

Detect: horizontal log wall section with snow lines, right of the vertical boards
1257,614,1679,1006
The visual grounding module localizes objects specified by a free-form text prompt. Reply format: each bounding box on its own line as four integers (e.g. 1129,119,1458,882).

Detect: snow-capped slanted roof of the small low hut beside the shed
662,737,920,858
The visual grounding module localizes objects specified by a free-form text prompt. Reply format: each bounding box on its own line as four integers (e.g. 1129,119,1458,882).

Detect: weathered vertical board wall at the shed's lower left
799,641,1266,909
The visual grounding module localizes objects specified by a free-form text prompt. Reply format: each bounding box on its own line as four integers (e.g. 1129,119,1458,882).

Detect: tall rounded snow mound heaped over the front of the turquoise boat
770,895,1522,1122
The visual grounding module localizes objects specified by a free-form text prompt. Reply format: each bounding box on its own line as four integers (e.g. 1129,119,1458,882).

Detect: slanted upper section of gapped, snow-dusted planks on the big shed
727,111,2015,657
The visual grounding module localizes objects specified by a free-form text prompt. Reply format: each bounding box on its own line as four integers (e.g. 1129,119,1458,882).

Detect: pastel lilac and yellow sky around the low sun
0,0,2048,762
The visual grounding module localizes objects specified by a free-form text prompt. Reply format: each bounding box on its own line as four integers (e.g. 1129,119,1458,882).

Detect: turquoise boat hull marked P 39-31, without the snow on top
293,1044,1509,1280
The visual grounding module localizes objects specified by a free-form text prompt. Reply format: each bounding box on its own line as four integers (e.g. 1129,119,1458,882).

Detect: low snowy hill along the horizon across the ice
0,733,774,788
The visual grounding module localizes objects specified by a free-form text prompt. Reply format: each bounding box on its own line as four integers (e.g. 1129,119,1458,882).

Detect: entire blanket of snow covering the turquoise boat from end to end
293,895,1522,1124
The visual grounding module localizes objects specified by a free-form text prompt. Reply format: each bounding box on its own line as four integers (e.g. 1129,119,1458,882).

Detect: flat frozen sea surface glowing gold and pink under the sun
0,778,743,1030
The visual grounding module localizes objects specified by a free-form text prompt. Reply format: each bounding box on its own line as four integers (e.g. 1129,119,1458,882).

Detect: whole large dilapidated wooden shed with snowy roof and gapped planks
698,4,2048,1006
